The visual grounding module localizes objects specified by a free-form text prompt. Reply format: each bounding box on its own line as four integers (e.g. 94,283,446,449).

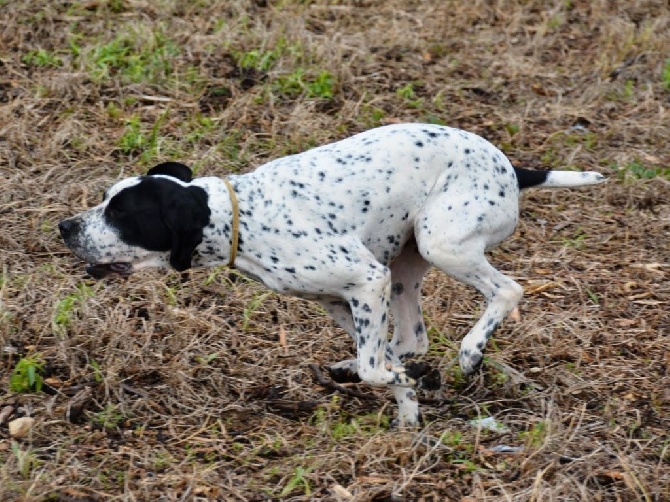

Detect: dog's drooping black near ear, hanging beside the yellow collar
163,187,211,272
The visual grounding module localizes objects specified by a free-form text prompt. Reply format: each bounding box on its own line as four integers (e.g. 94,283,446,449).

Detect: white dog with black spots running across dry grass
59,124,605,426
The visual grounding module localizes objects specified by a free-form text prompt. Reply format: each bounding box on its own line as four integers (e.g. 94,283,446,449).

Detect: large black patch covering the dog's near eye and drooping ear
104,177,211,272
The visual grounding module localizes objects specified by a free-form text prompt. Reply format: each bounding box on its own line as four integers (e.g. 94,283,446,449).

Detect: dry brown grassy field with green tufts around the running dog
0,0,670,502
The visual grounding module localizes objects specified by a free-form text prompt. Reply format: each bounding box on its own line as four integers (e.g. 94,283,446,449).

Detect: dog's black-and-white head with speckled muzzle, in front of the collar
58,162,210,278
